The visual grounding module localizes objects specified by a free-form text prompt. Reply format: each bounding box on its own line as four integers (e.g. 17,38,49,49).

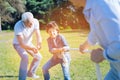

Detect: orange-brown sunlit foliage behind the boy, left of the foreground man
51,2,89,29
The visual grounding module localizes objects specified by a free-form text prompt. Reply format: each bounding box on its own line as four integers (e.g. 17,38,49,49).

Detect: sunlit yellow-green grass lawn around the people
0,31,109,80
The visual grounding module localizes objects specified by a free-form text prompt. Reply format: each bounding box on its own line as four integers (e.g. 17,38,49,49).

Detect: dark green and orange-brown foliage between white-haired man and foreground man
26,0,88,29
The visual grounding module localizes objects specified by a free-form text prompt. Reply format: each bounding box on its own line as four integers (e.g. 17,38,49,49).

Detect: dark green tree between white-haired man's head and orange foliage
26,0,54,29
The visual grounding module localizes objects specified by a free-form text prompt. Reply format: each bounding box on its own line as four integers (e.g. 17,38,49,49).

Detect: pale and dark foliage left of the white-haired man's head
0,0,25,29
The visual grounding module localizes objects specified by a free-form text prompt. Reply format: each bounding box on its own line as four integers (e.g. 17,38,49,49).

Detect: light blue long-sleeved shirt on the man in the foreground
83,0,120,62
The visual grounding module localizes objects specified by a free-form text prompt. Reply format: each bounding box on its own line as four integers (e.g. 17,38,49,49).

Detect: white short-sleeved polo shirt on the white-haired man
13,19,39,44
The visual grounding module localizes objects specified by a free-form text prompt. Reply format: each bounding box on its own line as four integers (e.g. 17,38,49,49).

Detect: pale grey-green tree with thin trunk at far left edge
0,0,25,31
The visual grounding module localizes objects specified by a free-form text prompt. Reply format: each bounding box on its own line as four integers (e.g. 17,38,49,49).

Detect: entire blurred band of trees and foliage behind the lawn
0,0,89,31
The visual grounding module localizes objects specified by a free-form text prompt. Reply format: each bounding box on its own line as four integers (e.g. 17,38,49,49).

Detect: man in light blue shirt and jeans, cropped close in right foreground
70,0,120,80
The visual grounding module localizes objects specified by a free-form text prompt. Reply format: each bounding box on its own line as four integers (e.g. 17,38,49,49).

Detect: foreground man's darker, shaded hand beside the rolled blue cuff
91,48,105,63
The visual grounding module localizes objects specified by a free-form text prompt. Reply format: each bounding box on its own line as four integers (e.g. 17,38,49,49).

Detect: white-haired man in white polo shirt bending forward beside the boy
13,12,42,80
